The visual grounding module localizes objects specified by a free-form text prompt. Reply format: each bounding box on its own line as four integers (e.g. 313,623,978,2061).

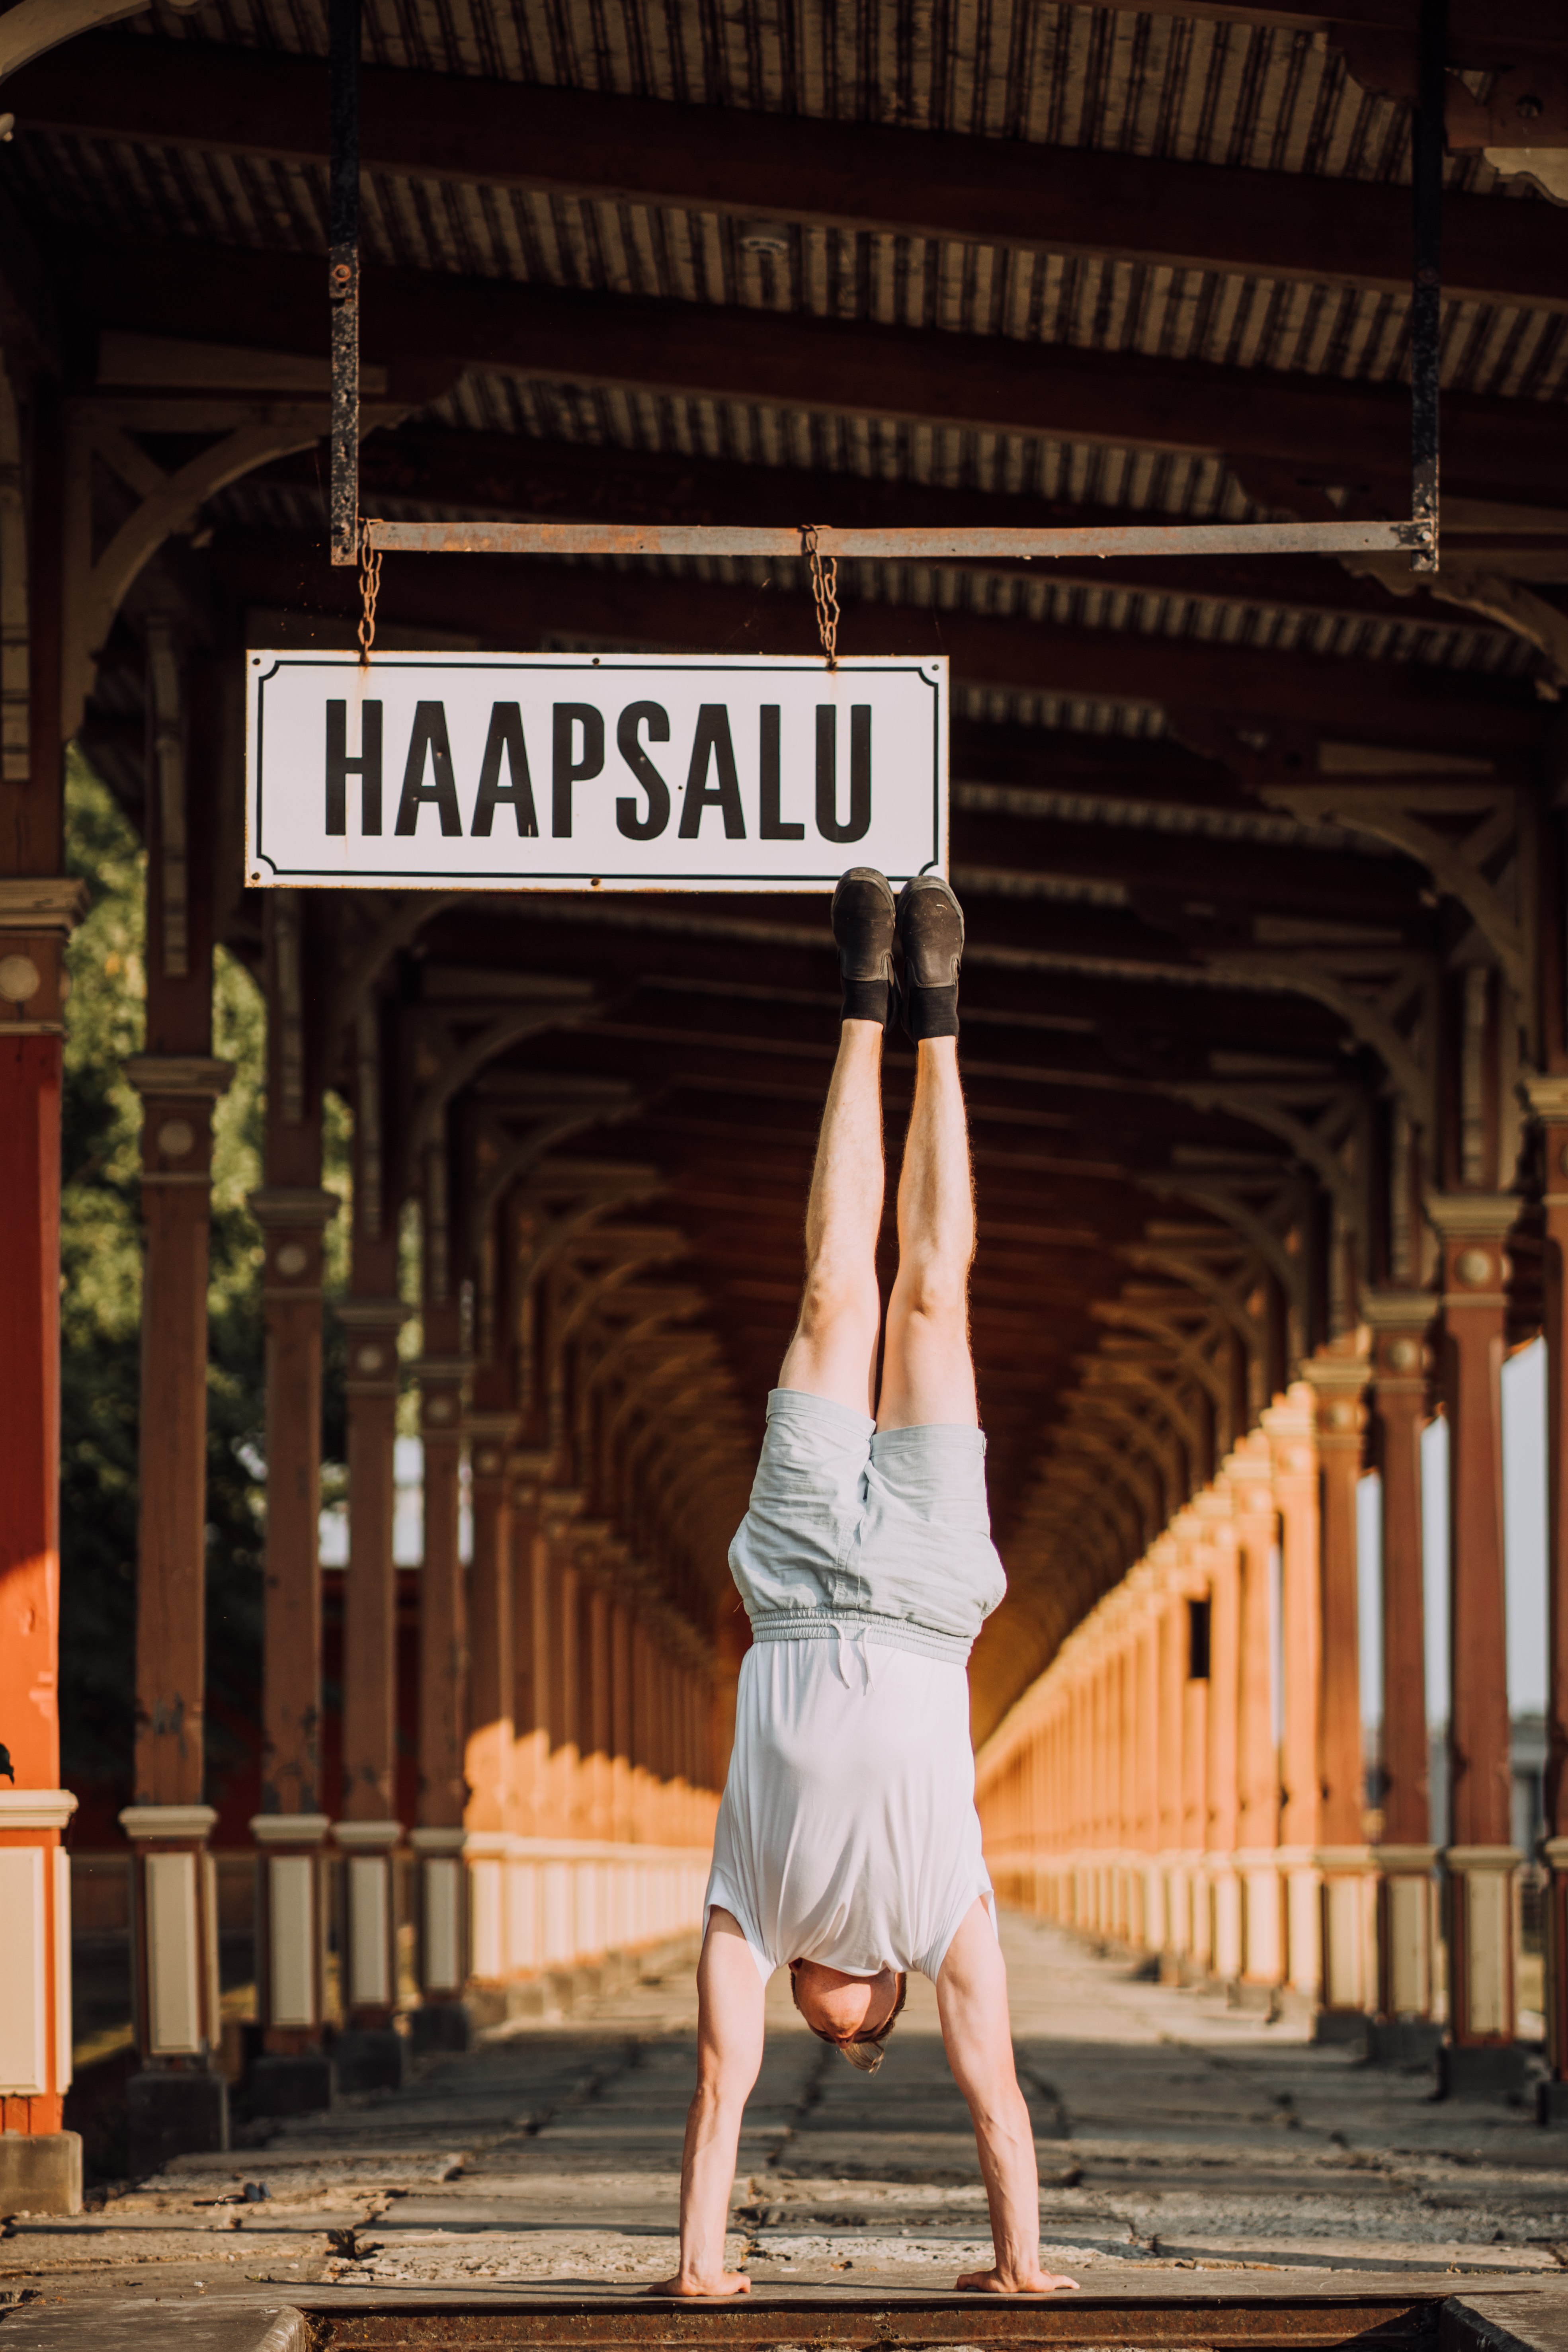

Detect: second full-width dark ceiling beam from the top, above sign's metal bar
70,236,1568,522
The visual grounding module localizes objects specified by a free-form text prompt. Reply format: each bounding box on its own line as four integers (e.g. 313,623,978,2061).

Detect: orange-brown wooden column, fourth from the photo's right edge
1302,1350,1378,2041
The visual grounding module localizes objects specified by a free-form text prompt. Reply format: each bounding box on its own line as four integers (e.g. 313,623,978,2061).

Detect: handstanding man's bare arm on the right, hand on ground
935,1901,1079,2295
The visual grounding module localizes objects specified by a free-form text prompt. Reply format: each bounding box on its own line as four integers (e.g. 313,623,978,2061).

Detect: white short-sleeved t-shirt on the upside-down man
703,1632,997,1981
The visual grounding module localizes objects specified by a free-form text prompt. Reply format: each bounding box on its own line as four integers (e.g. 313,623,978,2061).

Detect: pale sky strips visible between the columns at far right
1357,1341,1547,1724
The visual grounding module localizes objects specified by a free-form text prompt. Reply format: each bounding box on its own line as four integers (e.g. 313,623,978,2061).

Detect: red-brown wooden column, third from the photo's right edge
1363,1291,1436,2060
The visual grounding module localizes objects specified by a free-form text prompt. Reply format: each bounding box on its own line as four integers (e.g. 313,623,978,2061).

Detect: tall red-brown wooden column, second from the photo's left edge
120,635,237,2171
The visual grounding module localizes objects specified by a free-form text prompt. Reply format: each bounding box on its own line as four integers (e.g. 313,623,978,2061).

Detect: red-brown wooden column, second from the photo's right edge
1427,1192,1523,2093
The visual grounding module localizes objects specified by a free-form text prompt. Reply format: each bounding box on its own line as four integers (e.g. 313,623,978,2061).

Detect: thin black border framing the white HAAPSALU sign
244,654,943,891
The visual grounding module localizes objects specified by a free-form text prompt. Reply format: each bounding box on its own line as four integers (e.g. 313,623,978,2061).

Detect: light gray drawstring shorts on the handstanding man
729,1388,1006,1663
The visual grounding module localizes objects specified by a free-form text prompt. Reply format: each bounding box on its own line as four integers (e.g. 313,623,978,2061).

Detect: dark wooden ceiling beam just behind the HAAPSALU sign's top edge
214,531,1542,757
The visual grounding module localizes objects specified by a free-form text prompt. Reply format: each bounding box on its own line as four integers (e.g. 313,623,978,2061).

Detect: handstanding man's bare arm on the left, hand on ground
651,1907,762,2295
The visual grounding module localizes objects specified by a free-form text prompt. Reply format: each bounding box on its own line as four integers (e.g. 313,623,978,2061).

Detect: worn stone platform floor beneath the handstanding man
0,1919,1568,2352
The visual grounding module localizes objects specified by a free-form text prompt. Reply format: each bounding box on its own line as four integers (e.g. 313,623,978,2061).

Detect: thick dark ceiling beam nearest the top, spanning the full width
7,35,1568,311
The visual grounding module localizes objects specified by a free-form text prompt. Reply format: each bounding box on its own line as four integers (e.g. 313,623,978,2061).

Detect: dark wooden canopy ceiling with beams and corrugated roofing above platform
12,0,1568,1736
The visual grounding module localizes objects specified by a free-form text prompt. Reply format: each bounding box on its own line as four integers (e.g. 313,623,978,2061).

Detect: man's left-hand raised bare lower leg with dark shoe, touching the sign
778,865,893,1414
